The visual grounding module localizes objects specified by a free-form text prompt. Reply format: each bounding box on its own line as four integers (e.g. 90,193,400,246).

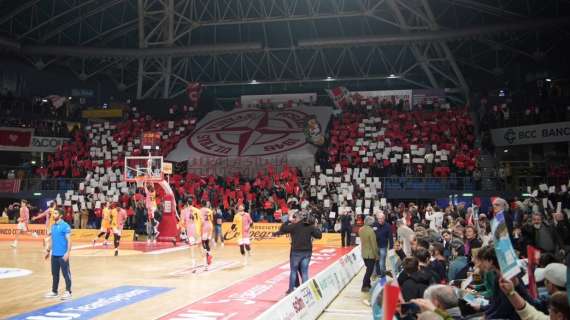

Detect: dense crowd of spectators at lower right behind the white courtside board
361,192,570,319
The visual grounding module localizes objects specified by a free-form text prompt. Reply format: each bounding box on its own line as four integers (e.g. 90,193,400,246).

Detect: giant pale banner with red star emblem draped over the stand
167,106,332,177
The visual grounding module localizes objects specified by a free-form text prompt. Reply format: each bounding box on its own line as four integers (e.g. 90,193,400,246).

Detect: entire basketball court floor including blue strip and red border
0,241,358,319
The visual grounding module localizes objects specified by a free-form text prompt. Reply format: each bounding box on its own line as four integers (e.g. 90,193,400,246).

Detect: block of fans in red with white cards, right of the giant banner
328,108,479,176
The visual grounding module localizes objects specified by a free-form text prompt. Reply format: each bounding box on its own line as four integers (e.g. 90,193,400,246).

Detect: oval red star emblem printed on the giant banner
188,109,309,157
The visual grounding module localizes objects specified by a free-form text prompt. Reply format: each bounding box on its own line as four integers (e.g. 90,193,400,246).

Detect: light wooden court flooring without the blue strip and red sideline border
0,241,289,320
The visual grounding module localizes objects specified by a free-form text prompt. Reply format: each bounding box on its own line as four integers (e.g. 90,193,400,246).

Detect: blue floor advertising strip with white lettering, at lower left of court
9,286,171,320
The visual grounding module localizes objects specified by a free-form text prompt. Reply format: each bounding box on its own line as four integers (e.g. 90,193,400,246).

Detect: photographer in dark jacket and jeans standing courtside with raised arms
273,210,323,294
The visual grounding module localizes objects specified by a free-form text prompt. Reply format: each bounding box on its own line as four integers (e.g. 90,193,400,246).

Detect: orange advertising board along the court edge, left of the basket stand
0,224,135,242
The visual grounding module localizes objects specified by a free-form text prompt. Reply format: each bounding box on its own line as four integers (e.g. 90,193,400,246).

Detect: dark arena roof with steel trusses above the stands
0,0,570,98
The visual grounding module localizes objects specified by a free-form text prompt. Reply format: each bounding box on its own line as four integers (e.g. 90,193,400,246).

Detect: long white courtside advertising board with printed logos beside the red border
256,246,364,320
